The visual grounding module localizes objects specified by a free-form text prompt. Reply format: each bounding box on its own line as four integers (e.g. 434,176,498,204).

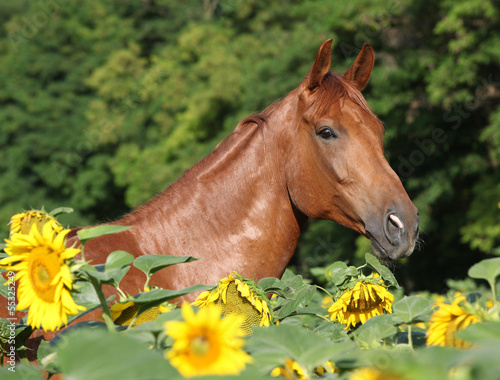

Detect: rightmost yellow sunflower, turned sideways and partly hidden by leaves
427,294,481,347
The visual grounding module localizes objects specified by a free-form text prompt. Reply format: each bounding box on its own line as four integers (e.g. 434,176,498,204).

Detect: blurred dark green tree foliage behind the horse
0,0,500,291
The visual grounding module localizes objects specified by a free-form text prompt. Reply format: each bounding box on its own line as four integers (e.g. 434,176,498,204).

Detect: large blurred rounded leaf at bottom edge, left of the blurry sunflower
56,328,182,380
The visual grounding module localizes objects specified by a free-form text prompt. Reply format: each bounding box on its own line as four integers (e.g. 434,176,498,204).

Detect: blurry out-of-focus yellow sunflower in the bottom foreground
165,303,252,377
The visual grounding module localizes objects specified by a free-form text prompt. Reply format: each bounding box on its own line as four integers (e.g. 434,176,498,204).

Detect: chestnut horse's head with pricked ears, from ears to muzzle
283,40,419,260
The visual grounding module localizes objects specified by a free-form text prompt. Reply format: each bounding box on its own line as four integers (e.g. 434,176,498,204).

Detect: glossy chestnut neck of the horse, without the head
118,104,306,276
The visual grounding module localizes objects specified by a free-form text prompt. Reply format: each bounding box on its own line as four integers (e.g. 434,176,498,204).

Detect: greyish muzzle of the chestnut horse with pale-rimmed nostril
366,206,419,260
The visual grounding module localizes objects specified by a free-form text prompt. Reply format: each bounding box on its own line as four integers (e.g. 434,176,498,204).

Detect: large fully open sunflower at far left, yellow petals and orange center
0,223,85,331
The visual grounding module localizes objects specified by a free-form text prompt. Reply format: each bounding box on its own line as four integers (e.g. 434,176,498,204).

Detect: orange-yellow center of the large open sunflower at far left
28,247,61,302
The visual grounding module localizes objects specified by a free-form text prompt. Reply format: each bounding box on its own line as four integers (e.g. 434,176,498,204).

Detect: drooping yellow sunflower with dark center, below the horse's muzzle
328,281,394,330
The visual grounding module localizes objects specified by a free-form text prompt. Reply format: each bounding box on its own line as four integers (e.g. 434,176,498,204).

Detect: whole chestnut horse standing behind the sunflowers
69,39,418,300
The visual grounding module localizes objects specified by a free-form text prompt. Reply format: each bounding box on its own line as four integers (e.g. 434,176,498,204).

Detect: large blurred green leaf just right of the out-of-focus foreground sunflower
245,324,359,373
